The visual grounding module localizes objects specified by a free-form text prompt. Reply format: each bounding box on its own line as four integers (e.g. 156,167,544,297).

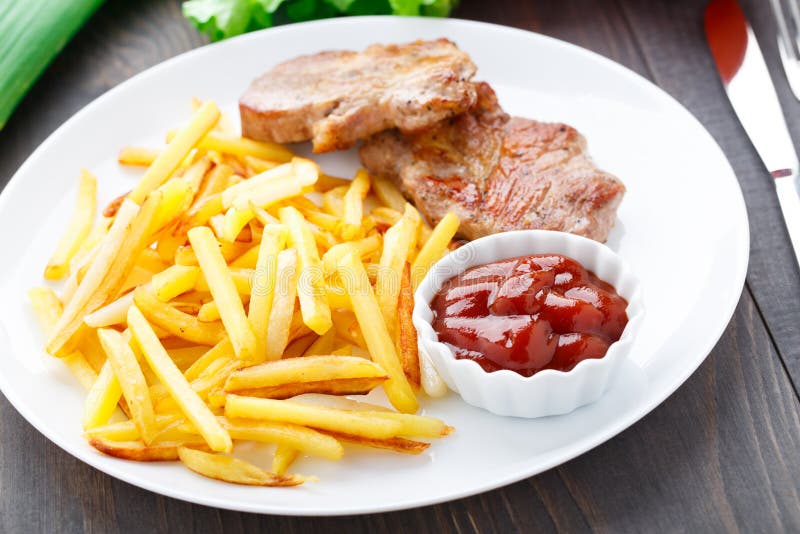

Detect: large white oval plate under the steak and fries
0,17,749,515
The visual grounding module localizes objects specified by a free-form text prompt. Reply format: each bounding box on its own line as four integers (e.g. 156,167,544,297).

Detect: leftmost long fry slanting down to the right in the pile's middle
187,226,256,360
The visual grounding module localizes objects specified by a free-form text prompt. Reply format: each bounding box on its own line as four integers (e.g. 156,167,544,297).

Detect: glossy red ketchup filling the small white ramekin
431,254,628,376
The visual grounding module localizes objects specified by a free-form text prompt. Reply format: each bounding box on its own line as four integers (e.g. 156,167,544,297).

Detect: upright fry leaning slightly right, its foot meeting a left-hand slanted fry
247,225,294,362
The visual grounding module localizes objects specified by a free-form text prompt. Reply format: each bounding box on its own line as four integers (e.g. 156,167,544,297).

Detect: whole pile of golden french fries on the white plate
29,101,459,486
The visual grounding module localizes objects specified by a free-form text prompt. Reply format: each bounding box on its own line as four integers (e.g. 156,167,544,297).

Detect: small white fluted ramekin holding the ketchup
413,230,644,417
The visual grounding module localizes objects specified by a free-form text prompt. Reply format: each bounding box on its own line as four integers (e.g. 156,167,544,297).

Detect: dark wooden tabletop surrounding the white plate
0,0,800,532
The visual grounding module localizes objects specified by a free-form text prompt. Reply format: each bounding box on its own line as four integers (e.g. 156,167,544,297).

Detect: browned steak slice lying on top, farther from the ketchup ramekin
239,39,476,152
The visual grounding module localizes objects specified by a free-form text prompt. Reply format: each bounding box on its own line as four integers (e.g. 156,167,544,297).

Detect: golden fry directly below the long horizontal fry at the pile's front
220,417,344,461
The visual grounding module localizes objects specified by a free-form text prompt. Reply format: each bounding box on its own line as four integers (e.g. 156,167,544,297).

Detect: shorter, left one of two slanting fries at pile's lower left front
97,328,157,445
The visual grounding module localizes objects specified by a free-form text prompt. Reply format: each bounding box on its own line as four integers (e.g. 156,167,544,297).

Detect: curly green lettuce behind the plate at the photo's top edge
183,0,458,41
